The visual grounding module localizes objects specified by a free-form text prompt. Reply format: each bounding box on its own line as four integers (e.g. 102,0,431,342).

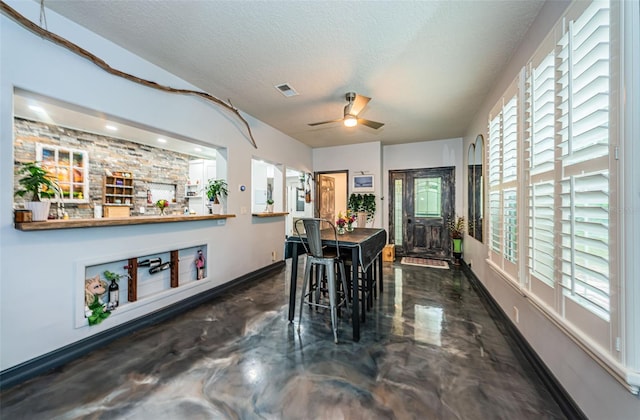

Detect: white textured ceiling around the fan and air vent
36,0,544,147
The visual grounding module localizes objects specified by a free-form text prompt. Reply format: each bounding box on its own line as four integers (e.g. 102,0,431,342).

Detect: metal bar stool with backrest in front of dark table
293,218,351,343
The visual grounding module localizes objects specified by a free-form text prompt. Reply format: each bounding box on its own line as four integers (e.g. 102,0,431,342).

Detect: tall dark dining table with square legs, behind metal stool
285,228,387,341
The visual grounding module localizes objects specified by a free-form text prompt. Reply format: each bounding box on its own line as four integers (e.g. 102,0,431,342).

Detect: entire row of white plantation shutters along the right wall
496,0,640,386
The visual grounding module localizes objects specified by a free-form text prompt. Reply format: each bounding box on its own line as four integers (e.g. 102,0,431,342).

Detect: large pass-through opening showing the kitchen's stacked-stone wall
14,88,227,219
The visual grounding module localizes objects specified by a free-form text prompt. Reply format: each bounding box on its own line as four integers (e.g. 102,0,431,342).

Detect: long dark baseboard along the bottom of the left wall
0,261,285,389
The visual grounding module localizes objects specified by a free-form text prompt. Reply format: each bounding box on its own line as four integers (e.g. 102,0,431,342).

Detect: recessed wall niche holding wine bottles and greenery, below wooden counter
77,244,208,327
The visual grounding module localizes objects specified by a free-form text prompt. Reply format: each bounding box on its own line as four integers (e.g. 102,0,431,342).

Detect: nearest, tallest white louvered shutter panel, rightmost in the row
558,2,610,318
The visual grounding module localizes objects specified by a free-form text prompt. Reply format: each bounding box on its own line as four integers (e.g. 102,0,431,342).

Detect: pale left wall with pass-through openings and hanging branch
0,1,312,370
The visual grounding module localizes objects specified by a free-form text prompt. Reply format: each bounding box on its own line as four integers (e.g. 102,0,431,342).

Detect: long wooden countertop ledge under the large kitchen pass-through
15,214,236,231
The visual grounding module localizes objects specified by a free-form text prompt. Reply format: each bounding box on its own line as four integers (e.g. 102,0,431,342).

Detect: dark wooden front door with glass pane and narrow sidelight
389,167,455,259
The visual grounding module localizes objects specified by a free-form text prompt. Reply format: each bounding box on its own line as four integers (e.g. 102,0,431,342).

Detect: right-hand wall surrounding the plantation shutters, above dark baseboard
462,0,640,419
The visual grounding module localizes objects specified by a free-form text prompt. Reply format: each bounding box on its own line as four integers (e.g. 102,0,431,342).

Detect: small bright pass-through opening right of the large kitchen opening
251,159,284,213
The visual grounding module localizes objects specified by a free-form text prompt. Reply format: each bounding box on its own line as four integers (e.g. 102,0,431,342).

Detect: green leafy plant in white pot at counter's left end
15,162,60,221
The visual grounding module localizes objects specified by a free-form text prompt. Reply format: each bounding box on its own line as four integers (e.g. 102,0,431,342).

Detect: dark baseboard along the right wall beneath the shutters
461,261,587,420
